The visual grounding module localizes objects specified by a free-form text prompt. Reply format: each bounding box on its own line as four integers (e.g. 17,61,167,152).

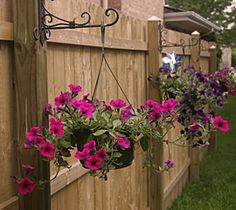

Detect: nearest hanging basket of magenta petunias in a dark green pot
14,84,179,193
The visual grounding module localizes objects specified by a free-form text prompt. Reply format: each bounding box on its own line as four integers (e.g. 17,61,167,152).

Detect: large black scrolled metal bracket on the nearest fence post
34,0,119,45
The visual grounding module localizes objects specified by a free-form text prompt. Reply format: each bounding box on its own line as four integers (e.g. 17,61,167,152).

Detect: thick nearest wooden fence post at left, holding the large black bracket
13,0,51,210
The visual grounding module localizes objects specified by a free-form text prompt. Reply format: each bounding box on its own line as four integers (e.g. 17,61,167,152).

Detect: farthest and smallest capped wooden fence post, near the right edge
209,42,217,150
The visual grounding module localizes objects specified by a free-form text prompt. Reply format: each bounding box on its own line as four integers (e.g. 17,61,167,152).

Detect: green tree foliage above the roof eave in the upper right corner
168,0,236,46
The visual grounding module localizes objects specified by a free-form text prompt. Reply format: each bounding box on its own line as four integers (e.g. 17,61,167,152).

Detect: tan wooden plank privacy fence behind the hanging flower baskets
0,0,215,210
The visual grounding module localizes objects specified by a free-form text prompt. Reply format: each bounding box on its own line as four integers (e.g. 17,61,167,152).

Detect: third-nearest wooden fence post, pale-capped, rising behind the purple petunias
189,31,201,179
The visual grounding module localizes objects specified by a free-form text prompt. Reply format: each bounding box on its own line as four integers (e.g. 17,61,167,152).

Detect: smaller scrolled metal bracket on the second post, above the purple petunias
159,25,199,54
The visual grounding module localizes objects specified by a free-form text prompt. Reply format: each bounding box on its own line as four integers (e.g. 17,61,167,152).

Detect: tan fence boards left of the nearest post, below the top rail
0,41,17,205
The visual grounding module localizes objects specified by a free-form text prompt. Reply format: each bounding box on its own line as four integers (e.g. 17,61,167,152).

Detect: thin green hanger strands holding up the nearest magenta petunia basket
92,21,131,105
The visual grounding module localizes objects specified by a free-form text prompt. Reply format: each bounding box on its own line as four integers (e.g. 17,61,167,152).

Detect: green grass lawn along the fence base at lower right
170,97,236,210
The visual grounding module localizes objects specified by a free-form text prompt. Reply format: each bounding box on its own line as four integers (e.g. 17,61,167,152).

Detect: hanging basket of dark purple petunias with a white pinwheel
156,53,232,147
